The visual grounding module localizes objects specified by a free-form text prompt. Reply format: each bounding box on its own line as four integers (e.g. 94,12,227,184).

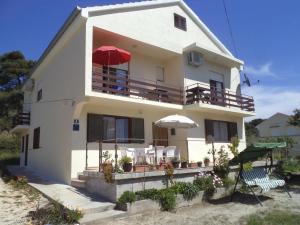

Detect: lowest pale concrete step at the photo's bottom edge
79,210,127,225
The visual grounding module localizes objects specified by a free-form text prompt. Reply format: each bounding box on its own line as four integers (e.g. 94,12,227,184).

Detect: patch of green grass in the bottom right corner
247,210,300,225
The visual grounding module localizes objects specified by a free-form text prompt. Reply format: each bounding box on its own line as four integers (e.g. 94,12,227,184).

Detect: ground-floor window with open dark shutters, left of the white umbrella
87,114,145,143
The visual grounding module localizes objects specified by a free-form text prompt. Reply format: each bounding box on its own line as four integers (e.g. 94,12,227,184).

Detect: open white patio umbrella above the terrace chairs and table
154,114,199,163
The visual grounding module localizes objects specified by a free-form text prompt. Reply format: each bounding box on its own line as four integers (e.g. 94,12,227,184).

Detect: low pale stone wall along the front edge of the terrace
84,167,212,202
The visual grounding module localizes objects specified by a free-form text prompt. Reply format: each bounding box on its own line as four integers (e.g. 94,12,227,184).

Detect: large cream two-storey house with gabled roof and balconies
13,0,254,183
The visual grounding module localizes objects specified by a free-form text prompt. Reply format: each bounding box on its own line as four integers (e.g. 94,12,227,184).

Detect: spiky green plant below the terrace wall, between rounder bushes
171,182,199,201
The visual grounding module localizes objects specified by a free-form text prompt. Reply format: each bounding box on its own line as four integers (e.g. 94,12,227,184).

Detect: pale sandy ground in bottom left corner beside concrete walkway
0,178,47,225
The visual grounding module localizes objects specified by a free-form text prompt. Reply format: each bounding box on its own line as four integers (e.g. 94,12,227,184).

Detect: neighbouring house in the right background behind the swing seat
256,113,300,156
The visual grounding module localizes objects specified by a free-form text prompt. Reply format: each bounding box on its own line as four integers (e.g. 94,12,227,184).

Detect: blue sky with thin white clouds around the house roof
0,0,300,118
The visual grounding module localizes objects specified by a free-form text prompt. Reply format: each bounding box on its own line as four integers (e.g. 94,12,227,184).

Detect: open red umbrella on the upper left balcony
93,46,131,66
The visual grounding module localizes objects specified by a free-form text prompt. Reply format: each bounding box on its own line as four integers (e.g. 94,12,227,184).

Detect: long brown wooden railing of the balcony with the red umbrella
92,71,183,105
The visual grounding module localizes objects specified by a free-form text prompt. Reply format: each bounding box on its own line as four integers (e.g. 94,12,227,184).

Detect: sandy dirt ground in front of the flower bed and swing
106,185,300,225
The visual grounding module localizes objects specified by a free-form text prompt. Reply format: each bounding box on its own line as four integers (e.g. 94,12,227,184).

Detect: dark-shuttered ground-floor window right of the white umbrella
205,120,238,142
